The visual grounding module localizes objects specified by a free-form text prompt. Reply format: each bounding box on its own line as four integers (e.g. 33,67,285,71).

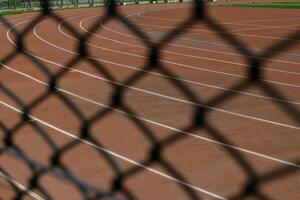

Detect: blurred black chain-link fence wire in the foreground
0,0,300,199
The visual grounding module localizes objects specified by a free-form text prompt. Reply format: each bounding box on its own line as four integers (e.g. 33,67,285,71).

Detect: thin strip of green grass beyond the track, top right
223,2,300,9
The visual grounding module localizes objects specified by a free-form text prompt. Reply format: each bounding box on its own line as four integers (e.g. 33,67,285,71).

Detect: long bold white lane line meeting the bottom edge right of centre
0,100,226,200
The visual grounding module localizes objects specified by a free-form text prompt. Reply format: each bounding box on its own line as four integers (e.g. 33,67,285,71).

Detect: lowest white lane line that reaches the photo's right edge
0,63,300,168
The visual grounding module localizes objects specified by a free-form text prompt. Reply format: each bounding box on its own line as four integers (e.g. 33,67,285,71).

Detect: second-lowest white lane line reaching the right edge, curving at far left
6,21,300,130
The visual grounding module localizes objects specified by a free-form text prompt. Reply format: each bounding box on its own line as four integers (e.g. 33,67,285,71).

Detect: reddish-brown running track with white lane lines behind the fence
0,4,300,199
